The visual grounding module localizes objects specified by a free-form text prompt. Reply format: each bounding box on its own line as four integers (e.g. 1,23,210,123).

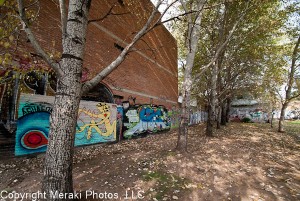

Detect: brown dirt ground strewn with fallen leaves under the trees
0,123,300,201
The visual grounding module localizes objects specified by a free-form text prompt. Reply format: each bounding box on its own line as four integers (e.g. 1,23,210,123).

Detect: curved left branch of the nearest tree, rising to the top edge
17,0,63,76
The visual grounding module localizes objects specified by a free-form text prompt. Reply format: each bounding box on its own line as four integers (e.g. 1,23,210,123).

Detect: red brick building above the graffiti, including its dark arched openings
0,0,178,141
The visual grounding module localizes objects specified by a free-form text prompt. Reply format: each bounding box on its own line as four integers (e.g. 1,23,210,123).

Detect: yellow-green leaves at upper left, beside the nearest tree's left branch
0,0,61,83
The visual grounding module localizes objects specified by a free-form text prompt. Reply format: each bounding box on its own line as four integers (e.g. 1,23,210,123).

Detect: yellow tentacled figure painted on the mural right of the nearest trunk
76,103,117,140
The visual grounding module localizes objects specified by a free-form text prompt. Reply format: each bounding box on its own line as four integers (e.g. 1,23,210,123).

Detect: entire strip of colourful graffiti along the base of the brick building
15,94,207,155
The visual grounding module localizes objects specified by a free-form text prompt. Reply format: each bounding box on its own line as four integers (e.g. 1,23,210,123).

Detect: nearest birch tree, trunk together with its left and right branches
17,0,179,196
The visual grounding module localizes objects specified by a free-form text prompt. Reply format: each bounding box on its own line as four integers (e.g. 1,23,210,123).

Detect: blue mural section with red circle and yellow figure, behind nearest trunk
15,94,117,155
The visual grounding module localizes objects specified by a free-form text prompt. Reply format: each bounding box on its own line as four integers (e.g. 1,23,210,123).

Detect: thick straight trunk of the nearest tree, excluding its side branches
42,1,89,200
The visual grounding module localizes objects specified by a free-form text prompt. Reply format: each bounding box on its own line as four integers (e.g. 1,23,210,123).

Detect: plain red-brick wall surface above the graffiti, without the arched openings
29,0,178,107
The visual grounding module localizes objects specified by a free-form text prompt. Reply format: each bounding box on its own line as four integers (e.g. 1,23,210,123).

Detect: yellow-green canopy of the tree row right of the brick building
174,0,299,108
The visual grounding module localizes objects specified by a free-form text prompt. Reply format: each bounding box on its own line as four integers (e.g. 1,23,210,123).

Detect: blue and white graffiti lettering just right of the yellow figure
123,105,171,138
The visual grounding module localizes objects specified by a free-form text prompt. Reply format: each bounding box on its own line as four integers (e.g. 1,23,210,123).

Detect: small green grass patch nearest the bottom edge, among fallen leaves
143,172,188,200
